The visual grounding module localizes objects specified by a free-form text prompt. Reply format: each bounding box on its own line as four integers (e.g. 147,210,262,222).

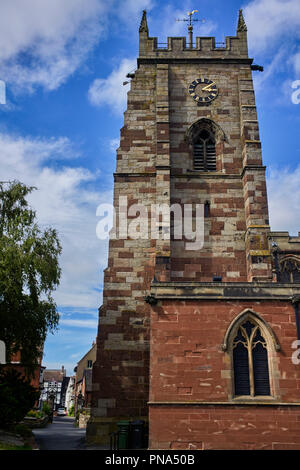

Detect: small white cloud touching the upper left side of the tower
88,59,137,114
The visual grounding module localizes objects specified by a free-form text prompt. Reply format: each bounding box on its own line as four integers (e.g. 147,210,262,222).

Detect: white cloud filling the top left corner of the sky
0,0,105,60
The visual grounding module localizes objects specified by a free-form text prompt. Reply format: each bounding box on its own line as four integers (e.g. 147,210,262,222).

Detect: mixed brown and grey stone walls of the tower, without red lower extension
87,9,298,443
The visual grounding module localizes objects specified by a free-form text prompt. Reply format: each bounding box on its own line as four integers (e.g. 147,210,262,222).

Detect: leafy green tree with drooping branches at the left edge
0,181,61,374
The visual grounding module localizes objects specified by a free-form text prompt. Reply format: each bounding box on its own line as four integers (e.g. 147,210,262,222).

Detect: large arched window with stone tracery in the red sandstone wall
233,320,270,397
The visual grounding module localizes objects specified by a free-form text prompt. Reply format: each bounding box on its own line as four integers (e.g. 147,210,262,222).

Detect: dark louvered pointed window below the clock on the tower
194,129,216,171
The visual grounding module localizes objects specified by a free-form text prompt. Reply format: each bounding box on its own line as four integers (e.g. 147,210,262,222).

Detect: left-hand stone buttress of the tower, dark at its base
88,62,156,442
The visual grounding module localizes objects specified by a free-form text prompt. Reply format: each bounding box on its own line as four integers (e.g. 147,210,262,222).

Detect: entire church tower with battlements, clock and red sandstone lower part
87,11,300,449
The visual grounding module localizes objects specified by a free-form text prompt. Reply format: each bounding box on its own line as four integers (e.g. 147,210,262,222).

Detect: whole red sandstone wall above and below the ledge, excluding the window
149,300,300,449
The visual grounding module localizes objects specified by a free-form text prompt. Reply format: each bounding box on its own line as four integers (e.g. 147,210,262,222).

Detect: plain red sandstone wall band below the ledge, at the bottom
149,405,300,450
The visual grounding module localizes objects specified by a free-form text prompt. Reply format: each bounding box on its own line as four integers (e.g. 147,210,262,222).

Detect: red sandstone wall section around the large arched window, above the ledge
150,300,300,402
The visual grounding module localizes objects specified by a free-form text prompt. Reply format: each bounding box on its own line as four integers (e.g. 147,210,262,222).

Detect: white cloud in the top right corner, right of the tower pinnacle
243,0,300,53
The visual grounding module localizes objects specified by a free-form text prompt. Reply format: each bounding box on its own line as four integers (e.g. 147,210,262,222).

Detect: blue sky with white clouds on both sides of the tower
0,0,300,374
